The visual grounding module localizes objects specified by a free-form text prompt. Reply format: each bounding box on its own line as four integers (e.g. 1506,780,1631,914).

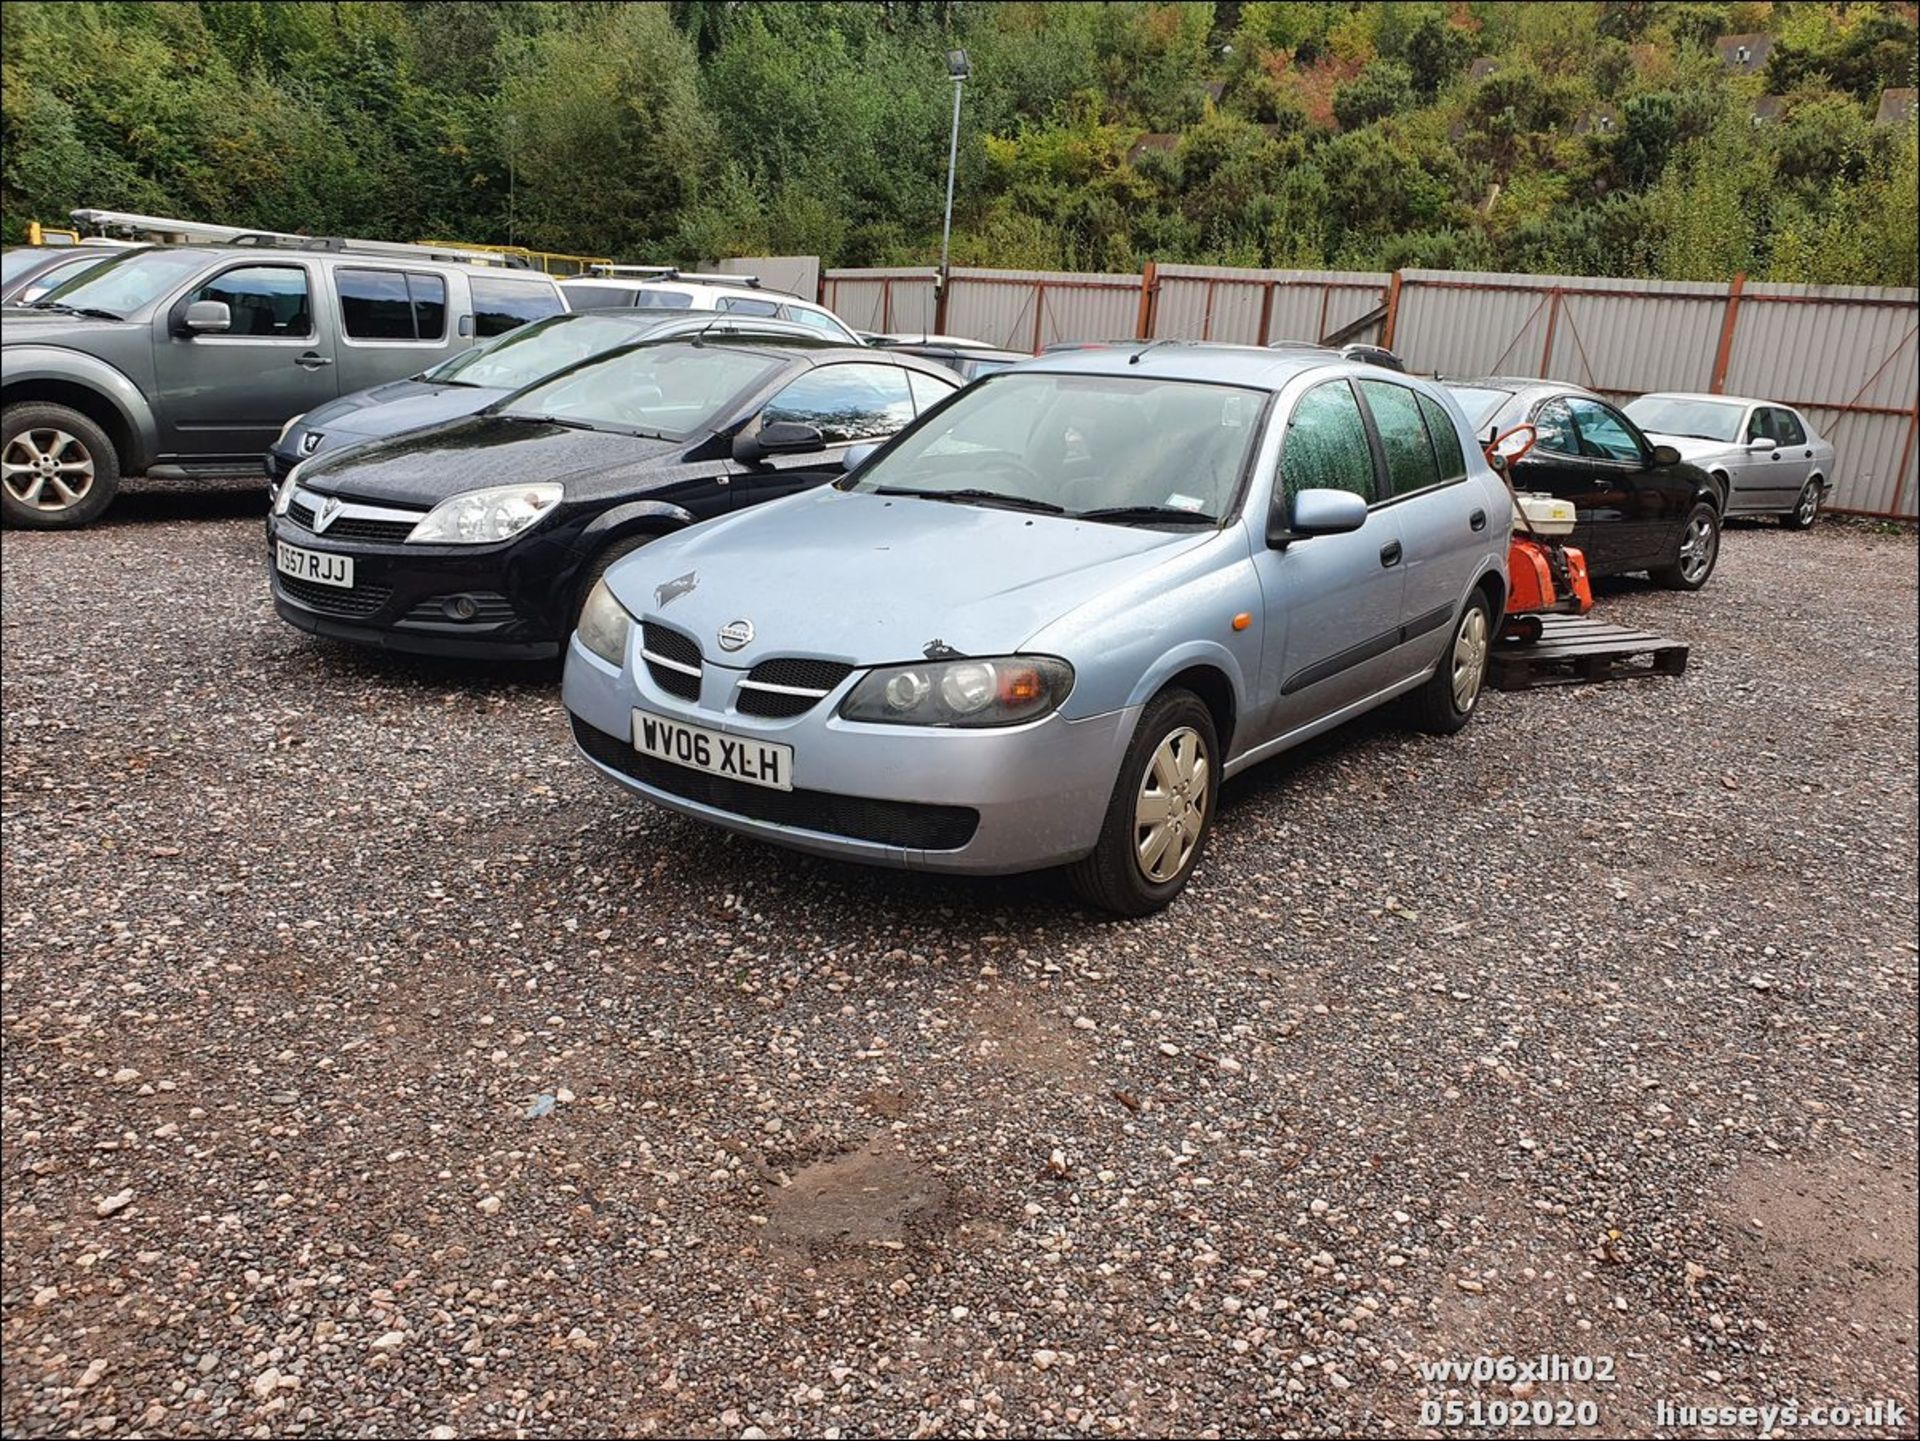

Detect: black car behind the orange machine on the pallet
1442,376,1720,591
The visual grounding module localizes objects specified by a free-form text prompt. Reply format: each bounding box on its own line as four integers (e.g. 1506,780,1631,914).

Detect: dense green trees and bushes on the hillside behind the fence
0,0,1920,286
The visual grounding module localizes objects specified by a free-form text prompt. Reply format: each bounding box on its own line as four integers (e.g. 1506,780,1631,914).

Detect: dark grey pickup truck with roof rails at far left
0,240,566,530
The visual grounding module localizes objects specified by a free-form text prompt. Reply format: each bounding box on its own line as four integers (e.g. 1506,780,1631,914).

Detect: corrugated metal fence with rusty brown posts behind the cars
820,265,1920,520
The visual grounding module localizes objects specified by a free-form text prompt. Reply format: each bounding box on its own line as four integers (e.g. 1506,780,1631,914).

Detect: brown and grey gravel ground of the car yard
0,493,1916,1435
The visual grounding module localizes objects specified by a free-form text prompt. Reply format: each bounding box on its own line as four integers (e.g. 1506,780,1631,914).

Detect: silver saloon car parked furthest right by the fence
1622,391,1834,530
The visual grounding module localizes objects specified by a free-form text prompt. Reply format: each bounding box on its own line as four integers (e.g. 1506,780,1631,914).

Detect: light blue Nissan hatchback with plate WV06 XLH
564,342,1511,915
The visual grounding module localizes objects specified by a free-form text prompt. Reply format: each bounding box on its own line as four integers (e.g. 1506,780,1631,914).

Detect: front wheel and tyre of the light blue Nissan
1068,691,1219,915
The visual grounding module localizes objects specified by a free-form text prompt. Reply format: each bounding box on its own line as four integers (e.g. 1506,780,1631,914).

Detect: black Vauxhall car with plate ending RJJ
267,334,960,660
